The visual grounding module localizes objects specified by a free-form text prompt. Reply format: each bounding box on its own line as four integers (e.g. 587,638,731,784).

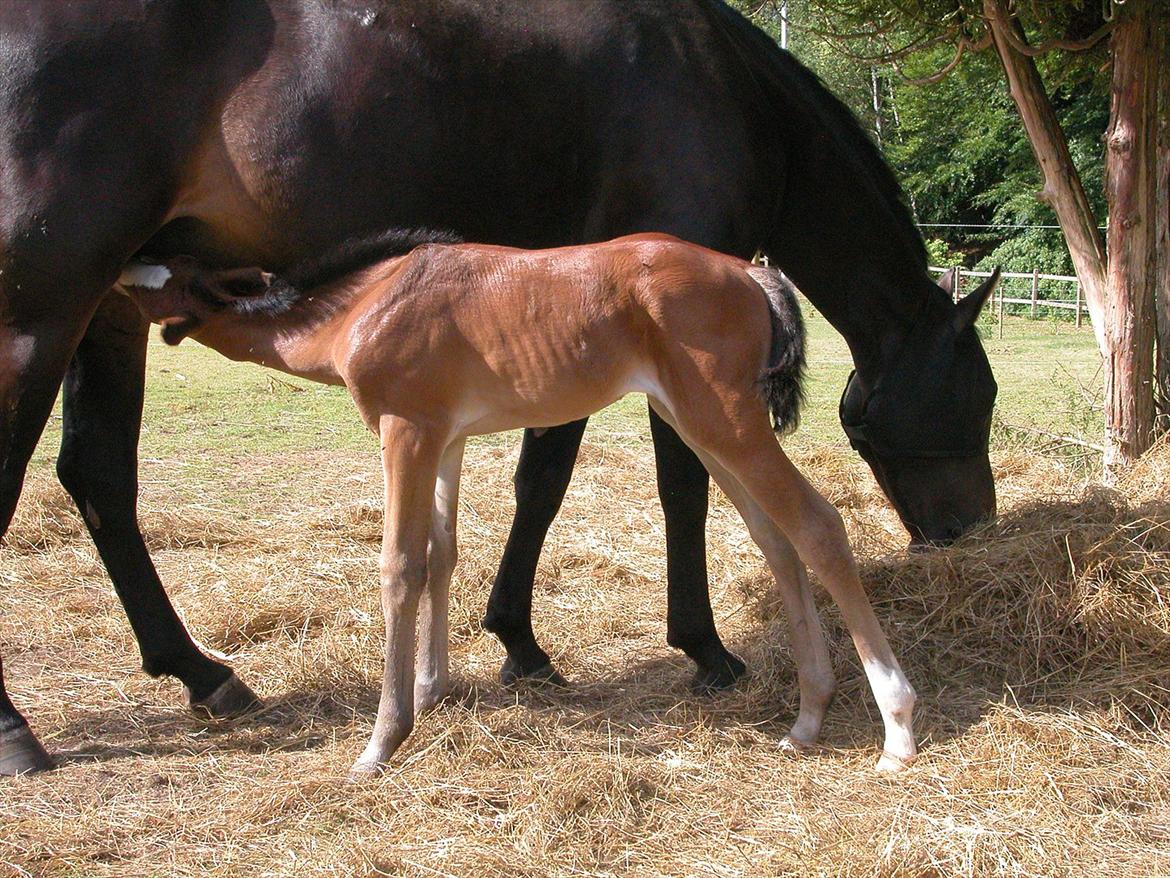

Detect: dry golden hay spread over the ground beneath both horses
0,439,1170,877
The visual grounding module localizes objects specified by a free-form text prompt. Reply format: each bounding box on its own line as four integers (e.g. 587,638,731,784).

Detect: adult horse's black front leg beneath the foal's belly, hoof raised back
483,420,586,686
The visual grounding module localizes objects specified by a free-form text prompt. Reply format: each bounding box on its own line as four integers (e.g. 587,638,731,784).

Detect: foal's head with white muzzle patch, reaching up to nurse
118,256,273,344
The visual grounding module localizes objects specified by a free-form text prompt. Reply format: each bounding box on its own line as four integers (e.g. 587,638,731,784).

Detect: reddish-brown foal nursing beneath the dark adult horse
121,234,916,773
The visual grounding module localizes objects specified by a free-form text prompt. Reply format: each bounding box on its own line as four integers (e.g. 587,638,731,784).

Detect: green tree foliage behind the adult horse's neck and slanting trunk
732,0,1109,274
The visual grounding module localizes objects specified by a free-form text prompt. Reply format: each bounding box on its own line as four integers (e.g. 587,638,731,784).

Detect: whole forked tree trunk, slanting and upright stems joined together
983,0,1165,478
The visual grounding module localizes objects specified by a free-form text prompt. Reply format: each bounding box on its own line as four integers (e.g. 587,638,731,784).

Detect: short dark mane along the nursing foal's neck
208,228,463,316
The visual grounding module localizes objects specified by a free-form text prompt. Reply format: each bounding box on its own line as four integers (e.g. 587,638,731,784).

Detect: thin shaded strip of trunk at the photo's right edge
1152,2,1170,432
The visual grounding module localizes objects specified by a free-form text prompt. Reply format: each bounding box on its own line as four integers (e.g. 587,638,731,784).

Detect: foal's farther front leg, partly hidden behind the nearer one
414,439,463,713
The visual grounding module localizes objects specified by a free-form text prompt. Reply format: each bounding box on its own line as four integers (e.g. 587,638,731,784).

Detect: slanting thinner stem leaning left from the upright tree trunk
983,0,1109,358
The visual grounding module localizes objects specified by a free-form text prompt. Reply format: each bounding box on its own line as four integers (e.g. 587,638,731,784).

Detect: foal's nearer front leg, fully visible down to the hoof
352,416,442,774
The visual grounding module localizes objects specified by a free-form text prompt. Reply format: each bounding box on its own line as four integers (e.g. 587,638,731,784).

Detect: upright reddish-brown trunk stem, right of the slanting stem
1104,0,1159,471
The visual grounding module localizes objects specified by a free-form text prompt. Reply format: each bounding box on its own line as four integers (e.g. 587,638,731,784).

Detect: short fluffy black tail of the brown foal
748,266,805,433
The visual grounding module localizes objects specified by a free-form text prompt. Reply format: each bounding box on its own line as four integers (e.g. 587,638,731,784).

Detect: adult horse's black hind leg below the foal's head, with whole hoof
57,293,257,716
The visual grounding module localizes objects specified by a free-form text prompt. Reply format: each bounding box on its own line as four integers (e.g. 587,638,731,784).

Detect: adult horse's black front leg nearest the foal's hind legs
651,407,745,691
